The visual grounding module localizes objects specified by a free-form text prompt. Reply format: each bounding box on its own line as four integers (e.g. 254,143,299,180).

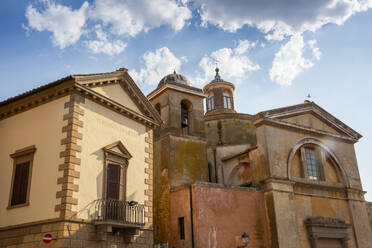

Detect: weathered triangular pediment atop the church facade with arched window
256,102,362,141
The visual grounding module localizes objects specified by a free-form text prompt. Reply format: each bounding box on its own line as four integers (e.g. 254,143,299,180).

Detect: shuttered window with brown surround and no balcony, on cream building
8,146,36,209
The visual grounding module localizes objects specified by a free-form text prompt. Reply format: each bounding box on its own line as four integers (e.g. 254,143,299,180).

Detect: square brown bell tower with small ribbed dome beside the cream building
147,72,209,243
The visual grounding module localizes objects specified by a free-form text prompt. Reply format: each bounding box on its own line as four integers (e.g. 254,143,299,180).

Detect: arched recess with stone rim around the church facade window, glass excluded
287,138,350,187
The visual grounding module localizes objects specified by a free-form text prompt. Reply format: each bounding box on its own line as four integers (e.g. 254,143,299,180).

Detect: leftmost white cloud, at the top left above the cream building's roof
26,0,89,49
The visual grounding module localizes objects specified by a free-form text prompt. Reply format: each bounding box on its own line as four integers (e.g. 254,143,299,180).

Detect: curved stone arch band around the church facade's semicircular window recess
287,137,350,187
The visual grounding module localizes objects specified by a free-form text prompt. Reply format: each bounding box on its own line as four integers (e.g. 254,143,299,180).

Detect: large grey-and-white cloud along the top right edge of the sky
195,0,372,40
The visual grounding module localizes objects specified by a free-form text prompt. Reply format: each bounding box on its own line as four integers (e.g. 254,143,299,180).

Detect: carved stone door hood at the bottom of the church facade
304,217,351,248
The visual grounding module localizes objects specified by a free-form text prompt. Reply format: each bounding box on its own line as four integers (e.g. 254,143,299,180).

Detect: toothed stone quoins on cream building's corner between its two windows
55,94,84,218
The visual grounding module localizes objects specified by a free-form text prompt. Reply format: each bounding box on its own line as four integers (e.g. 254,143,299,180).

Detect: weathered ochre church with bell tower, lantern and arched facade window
148,69,372,248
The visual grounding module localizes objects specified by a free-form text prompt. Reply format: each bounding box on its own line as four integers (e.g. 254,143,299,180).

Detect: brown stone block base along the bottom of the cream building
0,220,153,248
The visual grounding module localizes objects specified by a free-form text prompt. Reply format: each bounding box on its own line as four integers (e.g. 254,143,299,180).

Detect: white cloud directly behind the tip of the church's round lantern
192,40,260,85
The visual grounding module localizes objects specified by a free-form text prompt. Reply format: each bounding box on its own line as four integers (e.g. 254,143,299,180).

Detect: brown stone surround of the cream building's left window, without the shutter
7,145,36,209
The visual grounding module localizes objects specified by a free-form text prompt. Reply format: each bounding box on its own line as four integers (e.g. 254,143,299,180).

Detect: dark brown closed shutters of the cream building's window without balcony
11,162,30,206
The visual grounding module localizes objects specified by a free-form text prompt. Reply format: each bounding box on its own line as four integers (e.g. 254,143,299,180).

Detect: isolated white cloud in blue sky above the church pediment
270,34,321,85
